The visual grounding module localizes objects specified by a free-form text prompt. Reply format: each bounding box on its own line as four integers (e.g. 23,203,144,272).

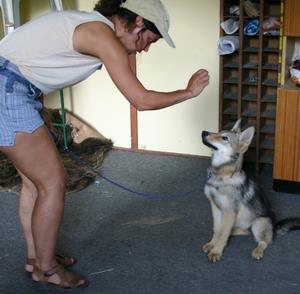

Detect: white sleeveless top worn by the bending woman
0,11,114,94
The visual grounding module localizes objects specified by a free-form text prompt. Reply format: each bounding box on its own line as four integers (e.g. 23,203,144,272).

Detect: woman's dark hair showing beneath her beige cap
94,0,162,37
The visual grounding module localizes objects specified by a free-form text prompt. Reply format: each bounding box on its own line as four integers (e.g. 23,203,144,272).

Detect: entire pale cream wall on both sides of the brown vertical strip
46,0,220,155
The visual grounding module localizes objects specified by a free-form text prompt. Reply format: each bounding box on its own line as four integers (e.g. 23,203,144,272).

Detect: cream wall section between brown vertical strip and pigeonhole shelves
138,0,220,155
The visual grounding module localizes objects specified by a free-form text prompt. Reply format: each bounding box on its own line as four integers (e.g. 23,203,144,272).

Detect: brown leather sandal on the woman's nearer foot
32,264,88,289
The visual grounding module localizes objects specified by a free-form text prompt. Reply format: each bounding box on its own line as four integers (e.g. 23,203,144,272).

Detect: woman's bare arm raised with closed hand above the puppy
73,22,209,110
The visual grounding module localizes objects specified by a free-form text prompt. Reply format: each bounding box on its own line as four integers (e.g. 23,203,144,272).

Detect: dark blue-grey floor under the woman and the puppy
0,150,300,294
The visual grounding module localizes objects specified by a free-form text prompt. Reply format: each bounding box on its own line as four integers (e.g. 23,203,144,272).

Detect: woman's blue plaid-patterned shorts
0,57,44,146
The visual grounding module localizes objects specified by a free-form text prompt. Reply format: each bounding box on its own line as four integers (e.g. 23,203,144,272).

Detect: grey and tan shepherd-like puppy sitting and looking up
202,119,300,262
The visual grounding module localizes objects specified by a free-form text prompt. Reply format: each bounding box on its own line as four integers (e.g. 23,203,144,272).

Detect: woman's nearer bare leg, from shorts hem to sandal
0,126,84,284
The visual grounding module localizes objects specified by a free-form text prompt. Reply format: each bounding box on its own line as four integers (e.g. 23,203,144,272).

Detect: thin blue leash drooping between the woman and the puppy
63,148,198,201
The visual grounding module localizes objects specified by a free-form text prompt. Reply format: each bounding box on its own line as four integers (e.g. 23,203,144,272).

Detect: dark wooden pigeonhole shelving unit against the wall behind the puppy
219,0,283,172
